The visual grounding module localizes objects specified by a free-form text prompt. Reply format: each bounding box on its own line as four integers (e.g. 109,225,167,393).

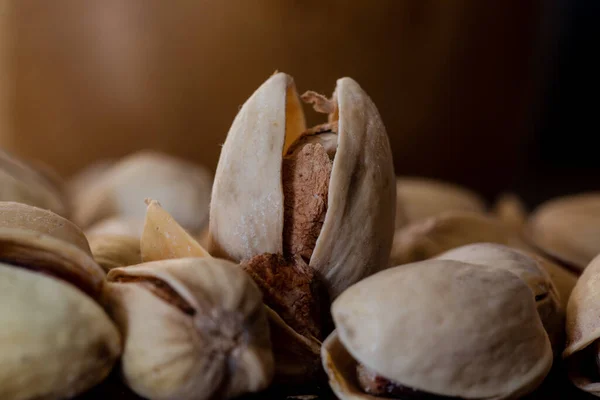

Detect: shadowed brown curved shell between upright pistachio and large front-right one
390,211,526,265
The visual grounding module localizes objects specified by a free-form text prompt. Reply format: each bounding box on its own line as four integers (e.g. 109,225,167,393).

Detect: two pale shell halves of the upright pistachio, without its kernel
209,73,396,298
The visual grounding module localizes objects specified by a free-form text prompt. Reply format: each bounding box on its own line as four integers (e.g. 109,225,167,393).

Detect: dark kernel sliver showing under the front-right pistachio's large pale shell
356,364,463,400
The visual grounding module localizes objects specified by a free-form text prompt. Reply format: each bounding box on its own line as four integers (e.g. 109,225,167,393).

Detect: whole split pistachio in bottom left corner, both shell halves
0,203,121,400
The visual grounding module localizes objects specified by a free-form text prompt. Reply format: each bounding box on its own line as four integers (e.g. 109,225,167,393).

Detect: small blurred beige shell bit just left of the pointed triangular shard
89,235,142,272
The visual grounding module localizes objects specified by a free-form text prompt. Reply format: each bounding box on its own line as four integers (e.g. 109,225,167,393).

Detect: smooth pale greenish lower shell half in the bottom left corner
0,264,121,400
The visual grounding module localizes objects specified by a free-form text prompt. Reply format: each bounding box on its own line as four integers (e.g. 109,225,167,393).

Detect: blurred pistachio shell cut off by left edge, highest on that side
0,150,68,216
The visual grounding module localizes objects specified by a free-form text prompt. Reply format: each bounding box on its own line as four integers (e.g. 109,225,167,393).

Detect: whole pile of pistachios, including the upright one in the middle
0,73,600,400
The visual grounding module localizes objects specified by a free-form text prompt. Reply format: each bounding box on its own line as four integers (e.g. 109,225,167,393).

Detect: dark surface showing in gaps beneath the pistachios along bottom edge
77,364,597,400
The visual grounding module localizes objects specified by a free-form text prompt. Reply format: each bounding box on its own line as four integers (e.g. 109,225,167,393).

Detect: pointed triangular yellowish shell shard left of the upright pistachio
141,199,210,262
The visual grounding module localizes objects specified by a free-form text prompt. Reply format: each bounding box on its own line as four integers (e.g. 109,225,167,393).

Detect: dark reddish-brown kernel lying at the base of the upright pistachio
242,254,328,339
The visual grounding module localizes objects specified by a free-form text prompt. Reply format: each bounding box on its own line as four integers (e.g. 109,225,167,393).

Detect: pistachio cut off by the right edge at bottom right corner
563,256,600,397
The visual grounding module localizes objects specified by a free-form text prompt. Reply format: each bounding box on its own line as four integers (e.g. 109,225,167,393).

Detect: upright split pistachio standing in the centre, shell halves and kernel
209,73,396,298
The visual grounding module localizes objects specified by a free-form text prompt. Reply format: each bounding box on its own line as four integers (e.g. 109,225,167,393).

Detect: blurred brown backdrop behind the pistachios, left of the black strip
0,0,576,200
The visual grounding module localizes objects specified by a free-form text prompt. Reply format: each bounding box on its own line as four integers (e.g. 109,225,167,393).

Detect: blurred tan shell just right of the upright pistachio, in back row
396,176,486,229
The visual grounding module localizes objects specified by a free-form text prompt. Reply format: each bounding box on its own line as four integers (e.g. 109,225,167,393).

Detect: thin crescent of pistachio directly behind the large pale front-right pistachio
436,243,565,354
